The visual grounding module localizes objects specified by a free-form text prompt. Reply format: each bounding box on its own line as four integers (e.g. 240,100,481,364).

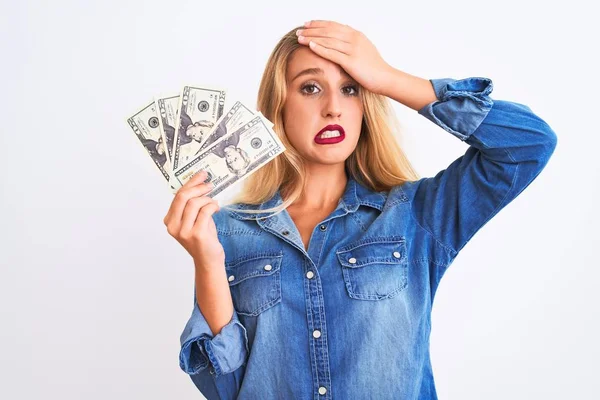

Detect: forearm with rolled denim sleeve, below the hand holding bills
179,266,249,399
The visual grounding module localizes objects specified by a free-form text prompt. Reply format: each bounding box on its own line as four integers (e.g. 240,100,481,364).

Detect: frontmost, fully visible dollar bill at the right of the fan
173,112,286,197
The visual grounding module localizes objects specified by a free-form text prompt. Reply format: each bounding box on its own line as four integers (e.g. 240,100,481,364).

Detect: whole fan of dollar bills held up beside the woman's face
127,86,286,197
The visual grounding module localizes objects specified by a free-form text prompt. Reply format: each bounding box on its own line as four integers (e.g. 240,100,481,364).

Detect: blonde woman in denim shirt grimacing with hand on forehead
164,21,557,399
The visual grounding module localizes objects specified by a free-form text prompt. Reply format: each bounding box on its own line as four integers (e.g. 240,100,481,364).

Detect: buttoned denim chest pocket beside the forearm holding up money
225,252,283,316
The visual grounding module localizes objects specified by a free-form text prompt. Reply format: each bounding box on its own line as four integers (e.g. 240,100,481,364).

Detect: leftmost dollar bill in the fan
127,101,175,186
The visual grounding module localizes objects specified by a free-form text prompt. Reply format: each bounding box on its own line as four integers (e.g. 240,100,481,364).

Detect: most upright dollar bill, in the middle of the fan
172,86,225,171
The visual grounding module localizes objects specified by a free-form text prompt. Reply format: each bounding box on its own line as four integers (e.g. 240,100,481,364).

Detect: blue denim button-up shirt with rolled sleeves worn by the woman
179,77,557,400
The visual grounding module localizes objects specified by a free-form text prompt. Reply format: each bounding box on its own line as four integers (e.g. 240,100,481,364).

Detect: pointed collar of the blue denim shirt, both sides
230,176,387,219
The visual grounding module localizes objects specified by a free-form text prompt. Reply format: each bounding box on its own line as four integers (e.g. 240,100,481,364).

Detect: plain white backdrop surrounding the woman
0,0,600,400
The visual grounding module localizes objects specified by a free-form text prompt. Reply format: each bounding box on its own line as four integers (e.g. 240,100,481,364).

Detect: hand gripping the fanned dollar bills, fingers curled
163,171,225,267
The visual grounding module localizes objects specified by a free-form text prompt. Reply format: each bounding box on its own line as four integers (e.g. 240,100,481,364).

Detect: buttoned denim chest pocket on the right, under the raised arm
336,236,408,300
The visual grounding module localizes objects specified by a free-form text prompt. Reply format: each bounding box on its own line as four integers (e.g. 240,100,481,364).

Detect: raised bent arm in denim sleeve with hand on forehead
296,20,557,276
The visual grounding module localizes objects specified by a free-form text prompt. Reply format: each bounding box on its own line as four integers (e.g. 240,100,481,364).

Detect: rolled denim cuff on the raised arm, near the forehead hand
418,77,494,141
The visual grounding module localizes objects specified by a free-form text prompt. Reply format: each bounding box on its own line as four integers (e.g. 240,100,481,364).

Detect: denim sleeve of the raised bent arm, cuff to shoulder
406,77,557,256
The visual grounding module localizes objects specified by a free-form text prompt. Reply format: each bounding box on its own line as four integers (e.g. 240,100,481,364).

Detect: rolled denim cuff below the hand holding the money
179,303,249,376
